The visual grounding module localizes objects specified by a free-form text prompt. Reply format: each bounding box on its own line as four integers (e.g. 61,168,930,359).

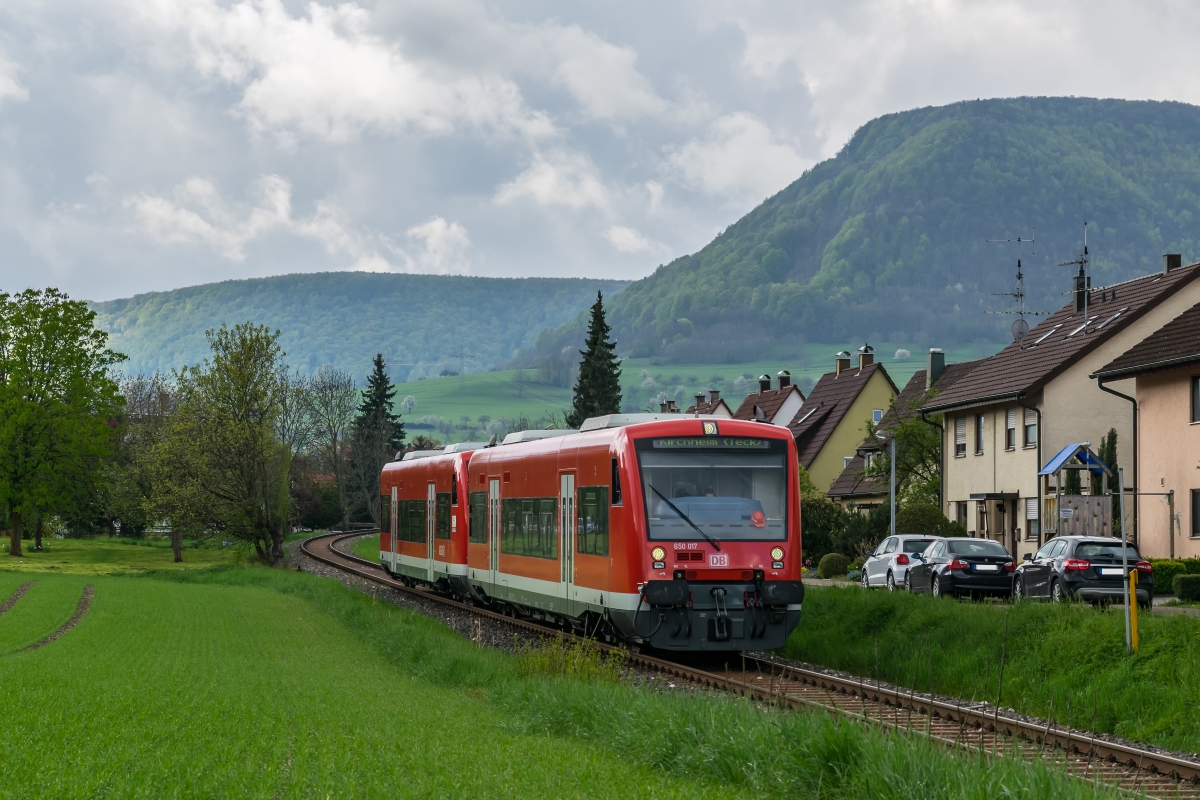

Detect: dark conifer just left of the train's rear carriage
350,353,404,525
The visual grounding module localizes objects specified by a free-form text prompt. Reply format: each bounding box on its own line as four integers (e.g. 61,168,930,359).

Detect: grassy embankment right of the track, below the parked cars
782,587,1200,752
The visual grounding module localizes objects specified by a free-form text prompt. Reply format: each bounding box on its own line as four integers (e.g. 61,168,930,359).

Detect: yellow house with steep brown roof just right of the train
787,344,898,492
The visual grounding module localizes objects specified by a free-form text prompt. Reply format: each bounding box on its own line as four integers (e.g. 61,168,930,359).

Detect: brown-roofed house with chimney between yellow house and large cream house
829,348,982,512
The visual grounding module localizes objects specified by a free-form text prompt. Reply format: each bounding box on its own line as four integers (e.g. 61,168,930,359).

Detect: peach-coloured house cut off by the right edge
1094,298,1200,558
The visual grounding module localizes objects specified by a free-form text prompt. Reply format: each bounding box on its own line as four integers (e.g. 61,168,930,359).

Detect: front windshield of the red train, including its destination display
635,437,788,541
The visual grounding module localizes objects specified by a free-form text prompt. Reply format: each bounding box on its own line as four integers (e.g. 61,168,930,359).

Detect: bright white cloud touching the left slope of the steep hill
665,113,810,199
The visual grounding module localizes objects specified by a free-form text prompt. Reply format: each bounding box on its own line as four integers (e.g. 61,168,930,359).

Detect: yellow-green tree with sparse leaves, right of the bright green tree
150,323,292,566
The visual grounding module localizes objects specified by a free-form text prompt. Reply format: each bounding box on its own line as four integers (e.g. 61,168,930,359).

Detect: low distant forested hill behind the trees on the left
92,272,628,380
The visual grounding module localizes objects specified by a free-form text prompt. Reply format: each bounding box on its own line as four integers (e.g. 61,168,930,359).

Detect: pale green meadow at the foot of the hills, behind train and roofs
396,342,998,444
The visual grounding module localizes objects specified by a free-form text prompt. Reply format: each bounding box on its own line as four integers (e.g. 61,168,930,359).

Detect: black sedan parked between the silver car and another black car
908,536,1016,597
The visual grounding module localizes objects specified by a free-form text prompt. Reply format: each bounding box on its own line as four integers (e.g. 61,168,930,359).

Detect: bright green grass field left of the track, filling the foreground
0,551,1113,798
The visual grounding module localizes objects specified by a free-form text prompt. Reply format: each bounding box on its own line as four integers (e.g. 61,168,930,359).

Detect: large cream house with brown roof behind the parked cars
922,255,1200,555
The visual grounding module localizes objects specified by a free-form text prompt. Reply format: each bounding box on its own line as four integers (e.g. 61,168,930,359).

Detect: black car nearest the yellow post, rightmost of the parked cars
1013,536,1154,606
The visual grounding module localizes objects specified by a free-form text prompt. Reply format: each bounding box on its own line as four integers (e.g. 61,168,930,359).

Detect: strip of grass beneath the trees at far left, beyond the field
0,534,246,575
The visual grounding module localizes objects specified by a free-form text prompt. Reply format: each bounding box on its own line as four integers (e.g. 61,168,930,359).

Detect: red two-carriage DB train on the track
379,414,804,650
